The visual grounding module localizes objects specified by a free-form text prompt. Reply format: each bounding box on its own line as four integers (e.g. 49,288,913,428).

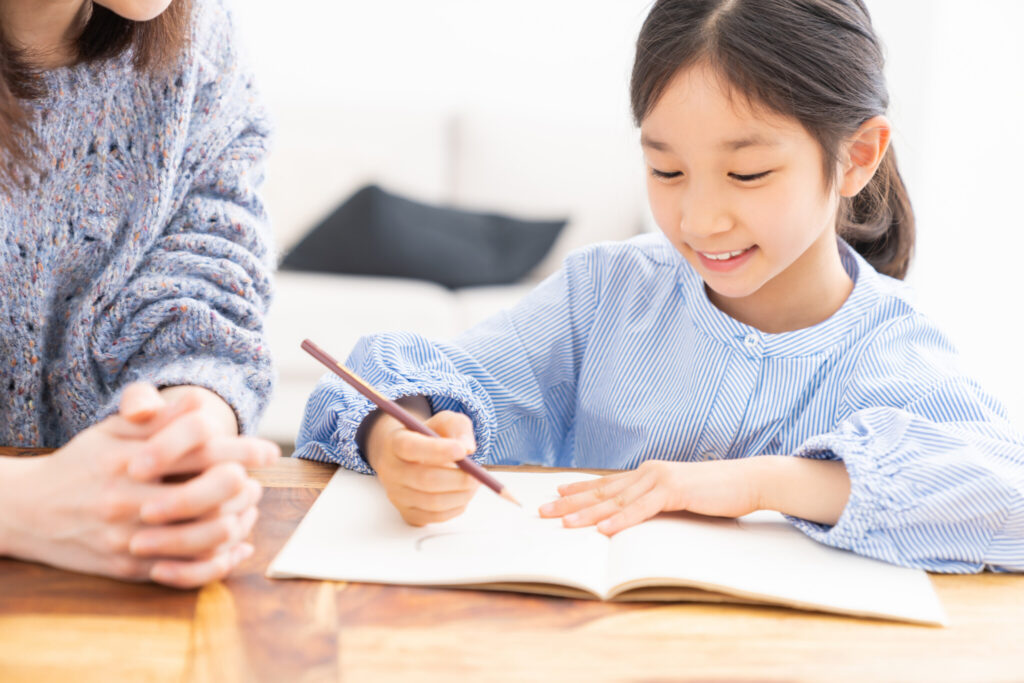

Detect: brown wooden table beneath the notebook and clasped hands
0,450,1024,683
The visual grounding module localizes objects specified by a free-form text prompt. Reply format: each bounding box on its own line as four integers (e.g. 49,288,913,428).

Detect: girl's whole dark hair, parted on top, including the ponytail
630,0,914,279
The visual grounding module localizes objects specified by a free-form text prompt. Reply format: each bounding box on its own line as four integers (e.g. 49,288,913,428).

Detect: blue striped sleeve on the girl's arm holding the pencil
296,249,598,473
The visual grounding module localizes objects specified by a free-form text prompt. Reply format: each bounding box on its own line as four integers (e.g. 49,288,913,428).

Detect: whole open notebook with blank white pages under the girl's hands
267,470,945,625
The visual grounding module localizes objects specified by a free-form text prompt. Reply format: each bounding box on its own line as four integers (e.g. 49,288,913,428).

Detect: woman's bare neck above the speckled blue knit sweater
0,0,92,69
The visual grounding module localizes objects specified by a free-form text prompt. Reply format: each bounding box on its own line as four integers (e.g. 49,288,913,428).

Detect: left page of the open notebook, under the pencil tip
267,470,609,594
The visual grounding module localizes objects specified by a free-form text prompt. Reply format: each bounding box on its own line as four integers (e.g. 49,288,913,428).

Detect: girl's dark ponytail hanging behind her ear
838,146,914,280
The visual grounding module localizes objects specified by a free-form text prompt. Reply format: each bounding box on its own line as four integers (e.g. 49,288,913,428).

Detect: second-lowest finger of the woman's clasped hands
129,506,258,558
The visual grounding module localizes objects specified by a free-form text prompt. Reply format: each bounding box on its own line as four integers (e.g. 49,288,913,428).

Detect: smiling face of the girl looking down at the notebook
640,62,849,322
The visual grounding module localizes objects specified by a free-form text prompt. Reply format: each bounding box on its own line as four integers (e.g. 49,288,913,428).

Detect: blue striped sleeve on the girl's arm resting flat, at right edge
791,315,1024,573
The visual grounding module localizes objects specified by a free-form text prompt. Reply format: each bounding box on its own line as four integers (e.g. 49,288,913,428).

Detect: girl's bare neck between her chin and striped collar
708,230,853,334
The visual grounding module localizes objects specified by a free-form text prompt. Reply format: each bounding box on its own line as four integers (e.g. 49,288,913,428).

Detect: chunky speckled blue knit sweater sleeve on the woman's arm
91,3,273,433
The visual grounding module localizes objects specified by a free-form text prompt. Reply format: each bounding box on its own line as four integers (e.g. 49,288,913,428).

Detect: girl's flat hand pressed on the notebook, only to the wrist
540,458,762,536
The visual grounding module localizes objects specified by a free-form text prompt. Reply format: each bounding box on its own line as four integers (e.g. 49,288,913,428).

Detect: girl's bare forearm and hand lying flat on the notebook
540,456,850,536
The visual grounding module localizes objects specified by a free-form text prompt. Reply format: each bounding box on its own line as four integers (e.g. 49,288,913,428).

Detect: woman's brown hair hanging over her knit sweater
0,0,191,190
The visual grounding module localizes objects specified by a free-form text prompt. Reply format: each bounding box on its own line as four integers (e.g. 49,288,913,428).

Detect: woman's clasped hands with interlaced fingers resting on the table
0,416,260,588
